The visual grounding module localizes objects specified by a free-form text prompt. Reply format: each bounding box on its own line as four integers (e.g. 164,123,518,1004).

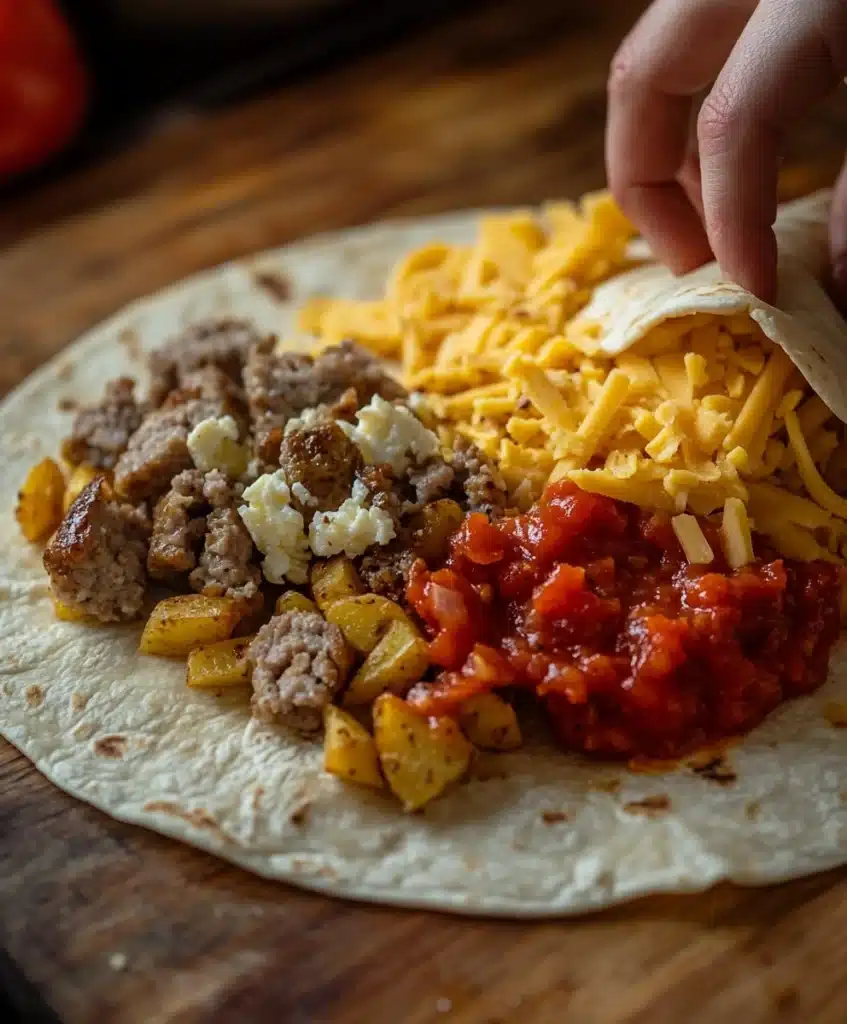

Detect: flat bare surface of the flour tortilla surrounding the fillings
0,193,847,918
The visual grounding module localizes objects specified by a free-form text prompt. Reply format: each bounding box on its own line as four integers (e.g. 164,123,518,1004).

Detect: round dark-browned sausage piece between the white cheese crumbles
280,420,362,519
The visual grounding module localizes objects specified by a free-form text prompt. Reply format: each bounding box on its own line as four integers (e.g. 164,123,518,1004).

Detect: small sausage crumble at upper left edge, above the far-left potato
61,377,145,469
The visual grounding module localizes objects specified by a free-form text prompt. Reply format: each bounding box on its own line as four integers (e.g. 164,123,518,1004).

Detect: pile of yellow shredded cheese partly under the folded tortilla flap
301,194,847,564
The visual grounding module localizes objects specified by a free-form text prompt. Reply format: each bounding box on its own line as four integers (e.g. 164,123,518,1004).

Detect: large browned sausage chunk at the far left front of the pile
44,476,150,623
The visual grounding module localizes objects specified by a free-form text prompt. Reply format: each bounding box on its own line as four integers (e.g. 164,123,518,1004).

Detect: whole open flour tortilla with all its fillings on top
0,188,847,914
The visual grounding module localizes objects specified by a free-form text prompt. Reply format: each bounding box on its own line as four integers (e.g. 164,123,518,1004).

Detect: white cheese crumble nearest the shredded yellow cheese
336,394,438,474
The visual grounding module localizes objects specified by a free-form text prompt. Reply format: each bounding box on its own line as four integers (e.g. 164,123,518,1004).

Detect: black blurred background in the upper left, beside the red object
0,0,467,193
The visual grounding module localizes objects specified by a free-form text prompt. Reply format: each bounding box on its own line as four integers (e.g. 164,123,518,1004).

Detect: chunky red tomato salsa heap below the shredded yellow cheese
409,482,843,758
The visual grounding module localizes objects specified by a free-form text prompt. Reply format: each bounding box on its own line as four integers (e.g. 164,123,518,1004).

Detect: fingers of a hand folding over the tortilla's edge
606,0,847,301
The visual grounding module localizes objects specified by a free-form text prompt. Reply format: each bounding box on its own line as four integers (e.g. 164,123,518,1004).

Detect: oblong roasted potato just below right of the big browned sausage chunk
138,594,247,657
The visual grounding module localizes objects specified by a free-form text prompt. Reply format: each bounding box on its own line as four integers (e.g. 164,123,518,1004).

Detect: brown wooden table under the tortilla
0,0,847,1024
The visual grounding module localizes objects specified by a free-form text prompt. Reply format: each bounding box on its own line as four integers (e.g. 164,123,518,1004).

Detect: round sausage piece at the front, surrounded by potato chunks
248,611,349,732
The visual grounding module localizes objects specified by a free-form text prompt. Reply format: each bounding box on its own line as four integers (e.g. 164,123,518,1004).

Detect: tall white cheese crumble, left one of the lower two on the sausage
239,469,311,583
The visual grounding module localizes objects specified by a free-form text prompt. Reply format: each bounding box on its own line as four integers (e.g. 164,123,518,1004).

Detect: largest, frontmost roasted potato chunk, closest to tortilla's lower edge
374,693,473,811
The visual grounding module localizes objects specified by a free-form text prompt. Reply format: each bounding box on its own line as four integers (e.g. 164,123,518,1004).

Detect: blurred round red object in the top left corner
0,0,88,179
